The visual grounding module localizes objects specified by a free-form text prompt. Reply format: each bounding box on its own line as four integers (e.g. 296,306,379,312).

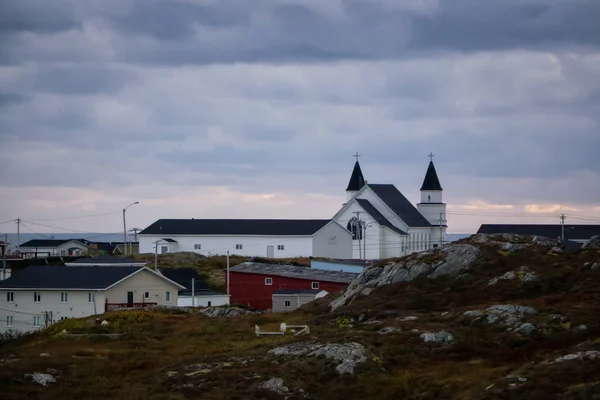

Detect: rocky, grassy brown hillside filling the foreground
0,235,600,400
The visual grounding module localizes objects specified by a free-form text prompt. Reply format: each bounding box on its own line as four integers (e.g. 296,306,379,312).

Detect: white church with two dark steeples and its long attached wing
139,154,447,260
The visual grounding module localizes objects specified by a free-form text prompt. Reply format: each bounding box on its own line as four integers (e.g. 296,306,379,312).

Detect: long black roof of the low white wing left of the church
140,219,330,236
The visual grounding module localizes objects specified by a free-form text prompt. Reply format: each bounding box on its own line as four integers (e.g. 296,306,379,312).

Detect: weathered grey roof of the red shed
229,262,358,283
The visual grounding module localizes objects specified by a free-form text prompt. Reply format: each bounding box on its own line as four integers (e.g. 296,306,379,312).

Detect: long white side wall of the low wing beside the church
139,235,313,258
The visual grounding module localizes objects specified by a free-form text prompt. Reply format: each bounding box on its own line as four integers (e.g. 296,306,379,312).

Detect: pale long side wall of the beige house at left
0,290,104,332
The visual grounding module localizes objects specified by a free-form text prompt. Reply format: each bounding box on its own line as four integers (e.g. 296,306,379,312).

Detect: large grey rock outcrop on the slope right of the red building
330,244,482,311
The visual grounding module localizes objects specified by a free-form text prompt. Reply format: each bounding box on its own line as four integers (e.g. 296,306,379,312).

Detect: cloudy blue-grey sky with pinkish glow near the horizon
0,0,600,233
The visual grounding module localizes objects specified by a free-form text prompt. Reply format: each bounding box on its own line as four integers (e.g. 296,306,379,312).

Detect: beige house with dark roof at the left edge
0,266,185,332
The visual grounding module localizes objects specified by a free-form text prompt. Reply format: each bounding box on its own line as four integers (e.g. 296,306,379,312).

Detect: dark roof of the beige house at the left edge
0,265,144,289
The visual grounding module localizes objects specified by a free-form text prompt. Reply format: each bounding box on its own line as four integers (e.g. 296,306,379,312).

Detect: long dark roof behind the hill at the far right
477,224,600,240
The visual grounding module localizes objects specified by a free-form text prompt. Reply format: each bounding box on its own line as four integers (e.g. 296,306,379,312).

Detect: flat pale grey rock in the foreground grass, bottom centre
269,342,367,375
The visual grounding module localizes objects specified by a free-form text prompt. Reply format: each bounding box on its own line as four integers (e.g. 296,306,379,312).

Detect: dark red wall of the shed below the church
225,271,348,310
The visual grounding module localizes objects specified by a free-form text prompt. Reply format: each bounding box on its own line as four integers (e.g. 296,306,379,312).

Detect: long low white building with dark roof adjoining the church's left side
139,218,352,258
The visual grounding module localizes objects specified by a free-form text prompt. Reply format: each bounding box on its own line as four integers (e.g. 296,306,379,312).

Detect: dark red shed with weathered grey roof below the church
226,262,358,310
